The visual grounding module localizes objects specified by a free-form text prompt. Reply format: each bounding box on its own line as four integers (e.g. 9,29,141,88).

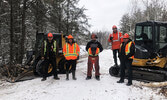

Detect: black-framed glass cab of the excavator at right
134,21,167,59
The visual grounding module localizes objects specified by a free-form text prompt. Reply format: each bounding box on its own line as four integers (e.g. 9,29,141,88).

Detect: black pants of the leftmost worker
43,58,57,77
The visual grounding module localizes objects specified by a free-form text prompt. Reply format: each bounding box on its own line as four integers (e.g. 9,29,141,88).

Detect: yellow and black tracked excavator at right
109,21,167,82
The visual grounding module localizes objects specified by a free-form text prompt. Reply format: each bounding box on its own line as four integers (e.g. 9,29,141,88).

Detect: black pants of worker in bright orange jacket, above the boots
66,60,77,71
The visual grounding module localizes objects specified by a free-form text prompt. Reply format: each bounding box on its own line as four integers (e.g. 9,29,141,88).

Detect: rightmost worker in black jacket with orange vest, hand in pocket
117,33,135,86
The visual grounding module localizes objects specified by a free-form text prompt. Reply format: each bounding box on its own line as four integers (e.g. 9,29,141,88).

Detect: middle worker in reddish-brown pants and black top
86,34,103,80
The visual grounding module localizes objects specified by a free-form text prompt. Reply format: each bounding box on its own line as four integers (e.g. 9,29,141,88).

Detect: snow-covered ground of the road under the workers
0,47,167,100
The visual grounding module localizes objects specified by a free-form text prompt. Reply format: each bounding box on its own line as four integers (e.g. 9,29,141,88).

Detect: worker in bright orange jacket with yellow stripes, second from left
63,35,80,80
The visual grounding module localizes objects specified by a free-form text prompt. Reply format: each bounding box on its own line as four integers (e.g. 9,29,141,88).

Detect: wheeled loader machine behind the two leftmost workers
12,33,66,82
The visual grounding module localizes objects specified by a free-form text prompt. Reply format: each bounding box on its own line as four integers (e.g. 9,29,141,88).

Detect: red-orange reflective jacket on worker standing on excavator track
108,32,123,50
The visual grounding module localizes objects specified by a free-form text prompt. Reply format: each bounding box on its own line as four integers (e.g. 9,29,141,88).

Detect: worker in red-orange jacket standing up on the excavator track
108,25,123,66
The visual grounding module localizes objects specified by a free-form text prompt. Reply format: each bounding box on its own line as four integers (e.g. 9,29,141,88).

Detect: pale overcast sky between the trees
79,0,130,31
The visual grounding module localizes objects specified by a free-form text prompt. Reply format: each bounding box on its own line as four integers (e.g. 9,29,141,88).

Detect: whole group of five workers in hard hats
41,25,135,86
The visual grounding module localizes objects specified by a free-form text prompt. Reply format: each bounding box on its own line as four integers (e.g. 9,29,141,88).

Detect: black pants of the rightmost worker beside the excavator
120,59,133,83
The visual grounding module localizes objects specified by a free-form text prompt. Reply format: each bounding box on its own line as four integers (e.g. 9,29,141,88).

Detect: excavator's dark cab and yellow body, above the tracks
132,21,167,68
